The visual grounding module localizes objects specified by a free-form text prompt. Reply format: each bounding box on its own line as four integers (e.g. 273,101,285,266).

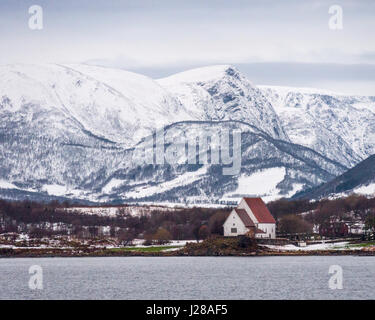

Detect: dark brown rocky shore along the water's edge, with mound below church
0,237,375,258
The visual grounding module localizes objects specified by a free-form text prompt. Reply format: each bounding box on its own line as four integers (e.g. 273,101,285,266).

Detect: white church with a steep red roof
223,198,276,239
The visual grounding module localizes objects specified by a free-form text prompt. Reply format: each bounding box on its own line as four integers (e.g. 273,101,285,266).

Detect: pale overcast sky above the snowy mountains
0,0,375,95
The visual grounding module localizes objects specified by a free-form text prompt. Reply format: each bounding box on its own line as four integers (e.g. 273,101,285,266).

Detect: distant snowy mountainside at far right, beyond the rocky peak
259,86,375,167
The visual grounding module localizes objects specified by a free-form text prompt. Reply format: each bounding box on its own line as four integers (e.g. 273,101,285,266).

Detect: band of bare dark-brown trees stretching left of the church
0,200,230,244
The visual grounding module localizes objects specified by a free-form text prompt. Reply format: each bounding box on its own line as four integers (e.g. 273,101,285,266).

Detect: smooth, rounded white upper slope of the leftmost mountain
0,65,191,146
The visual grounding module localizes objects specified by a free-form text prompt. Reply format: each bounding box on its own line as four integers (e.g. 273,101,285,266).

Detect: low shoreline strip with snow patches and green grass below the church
0,236,375,259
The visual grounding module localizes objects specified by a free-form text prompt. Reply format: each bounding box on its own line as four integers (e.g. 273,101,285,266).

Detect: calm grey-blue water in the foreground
0,256,375,300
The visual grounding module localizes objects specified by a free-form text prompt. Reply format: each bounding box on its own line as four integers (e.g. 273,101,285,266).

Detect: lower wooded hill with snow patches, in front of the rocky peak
97,121,346,203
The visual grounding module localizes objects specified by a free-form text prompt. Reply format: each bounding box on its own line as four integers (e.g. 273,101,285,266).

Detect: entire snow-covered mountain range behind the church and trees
0,65,375,203
